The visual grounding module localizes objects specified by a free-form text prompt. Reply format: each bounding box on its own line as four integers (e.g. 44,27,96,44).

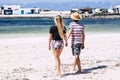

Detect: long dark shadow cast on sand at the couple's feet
63,65,107,77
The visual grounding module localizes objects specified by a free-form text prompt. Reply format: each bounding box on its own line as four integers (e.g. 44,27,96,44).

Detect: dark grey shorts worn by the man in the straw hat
71,43,82,55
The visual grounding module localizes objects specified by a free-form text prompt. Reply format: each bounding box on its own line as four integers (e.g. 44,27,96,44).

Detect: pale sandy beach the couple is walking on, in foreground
0,32,120,80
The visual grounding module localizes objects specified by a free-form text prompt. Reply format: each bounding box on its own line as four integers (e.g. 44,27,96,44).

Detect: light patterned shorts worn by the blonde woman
52,40,64,49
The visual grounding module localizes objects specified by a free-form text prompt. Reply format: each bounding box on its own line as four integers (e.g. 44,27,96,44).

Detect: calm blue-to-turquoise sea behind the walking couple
0,18,120,34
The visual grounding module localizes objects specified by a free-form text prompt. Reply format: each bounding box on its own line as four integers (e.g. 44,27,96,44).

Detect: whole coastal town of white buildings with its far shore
0,5,120,18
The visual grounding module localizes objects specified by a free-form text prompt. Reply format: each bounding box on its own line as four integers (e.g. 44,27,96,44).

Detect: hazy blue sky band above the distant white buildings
0,0,120,9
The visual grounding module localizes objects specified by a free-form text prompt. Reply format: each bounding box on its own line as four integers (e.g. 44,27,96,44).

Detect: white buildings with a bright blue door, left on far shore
1,5,40,15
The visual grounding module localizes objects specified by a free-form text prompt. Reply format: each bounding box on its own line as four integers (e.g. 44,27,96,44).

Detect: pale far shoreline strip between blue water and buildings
0,14,120,19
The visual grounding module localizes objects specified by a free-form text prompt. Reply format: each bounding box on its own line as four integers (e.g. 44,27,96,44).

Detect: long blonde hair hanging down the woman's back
54,15,64,39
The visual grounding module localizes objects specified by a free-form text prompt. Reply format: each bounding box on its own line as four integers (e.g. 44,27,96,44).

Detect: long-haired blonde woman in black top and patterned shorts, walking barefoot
48,15,67,76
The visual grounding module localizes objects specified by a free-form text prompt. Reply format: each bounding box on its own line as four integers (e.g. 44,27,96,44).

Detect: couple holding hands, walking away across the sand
48,12,85,76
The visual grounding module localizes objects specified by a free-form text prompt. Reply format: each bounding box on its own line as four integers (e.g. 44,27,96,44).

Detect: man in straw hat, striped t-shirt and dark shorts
68,12,85,72
